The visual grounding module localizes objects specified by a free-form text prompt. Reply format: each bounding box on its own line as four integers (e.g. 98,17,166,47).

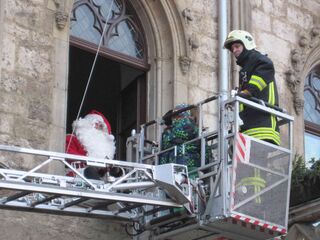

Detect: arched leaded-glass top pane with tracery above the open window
70,0,148,68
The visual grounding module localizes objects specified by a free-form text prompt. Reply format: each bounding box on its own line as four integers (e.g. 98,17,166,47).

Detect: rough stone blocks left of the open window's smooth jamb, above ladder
0,1,54,148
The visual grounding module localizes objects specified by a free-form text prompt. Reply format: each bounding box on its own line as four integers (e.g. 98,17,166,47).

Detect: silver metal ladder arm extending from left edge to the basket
0,145,191,221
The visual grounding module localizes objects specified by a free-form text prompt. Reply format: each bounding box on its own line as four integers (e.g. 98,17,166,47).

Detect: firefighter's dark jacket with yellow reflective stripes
237,49,280,145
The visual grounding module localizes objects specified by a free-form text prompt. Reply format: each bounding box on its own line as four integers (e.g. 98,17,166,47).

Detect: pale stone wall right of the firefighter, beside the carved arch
250,0,320,154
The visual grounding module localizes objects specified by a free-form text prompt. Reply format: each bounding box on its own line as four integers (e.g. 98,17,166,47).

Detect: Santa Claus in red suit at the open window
66,110,116,179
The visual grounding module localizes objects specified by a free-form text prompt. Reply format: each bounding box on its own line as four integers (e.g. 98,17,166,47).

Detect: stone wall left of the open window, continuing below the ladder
0,0,129,240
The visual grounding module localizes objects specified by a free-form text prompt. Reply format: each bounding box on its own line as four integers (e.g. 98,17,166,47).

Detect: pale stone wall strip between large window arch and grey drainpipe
175,0,219,130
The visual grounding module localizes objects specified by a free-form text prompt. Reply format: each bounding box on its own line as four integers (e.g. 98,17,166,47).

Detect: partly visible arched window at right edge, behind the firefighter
304,65,320,163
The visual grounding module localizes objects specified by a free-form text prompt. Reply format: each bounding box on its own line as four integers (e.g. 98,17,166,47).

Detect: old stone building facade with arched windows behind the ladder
0,0,320,239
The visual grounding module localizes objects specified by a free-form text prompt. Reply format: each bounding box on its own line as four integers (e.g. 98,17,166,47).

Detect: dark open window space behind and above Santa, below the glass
67,45,146,160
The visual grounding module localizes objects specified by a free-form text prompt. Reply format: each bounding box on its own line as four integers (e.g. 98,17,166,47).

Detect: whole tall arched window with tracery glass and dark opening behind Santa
67,0,149,159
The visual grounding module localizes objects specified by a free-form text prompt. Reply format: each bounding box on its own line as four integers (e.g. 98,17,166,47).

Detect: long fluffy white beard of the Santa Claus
73,118,116,159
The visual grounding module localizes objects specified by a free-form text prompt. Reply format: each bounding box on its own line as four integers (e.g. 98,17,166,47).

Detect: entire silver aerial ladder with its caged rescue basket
0,96,293,240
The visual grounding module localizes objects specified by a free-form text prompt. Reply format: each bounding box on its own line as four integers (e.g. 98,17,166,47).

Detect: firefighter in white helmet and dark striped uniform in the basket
224,30,280,145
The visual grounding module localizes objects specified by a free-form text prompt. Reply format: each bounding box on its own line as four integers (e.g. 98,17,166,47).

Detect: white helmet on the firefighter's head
224,30,256,51
